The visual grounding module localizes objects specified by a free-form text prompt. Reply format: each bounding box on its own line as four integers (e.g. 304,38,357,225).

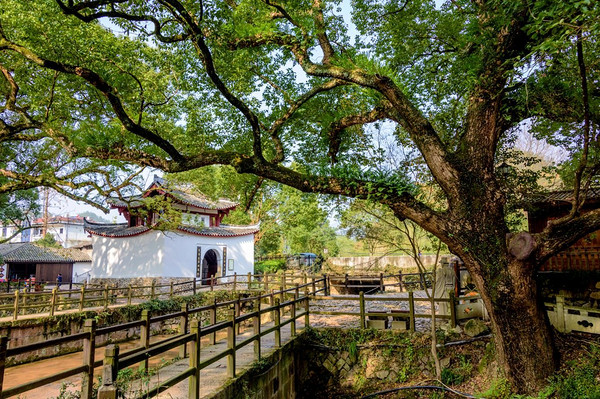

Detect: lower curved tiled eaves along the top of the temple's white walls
84,220,259,238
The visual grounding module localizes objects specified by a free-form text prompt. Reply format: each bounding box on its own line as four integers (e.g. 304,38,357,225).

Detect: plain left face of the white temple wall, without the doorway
92,231,166,278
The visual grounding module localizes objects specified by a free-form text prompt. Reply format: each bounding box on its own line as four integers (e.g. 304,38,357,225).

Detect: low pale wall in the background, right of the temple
323,255,436,274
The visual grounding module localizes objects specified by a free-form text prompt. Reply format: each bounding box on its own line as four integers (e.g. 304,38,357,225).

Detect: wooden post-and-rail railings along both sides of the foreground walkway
0,278,326,398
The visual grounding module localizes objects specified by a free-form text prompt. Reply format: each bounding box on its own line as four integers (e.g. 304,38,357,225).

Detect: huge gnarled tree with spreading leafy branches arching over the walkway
0,0,600,391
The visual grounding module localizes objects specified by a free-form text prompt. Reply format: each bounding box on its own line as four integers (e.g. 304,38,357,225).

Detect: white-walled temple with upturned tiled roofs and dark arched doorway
85,176,259,284
